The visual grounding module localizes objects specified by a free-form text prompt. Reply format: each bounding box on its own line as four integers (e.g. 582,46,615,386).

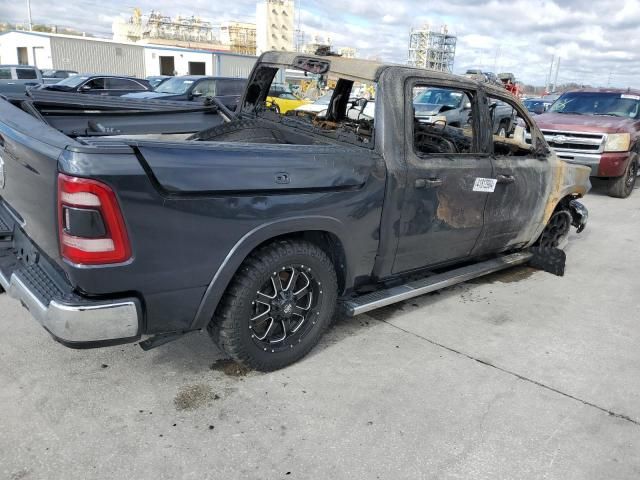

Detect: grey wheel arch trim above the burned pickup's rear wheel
191,216,353,329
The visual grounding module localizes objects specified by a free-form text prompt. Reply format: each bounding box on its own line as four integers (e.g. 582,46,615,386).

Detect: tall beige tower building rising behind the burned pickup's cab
256,0,295,55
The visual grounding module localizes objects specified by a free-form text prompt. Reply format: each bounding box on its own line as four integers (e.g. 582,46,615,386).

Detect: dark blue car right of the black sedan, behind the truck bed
126,75,247,110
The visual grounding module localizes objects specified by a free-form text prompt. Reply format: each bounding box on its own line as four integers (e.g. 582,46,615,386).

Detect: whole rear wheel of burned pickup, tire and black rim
209,240,338,371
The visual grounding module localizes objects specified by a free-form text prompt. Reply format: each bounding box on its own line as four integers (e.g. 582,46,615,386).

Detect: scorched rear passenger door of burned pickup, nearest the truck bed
393,80,492,273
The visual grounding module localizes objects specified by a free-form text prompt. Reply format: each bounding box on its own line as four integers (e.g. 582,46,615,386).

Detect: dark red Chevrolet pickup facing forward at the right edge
535,88,640,198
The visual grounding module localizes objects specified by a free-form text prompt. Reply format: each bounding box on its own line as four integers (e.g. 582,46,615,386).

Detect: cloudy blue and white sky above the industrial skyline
5,0,640,87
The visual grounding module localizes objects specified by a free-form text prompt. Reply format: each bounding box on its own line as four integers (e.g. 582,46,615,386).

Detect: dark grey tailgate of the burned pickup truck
0,100,74,262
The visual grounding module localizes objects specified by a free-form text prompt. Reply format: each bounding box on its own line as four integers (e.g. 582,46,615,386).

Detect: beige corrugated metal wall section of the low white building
51,37,144,77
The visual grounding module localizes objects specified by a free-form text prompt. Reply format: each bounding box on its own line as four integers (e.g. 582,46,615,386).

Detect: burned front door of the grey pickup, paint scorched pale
474,92,551,254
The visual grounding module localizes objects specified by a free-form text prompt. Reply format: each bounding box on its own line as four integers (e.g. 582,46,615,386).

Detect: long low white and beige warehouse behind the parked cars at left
0,31,256,77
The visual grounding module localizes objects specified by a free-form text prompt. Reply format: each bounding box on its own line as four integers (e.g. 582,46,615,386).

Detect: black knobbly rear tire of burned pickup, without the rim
208,240,338,372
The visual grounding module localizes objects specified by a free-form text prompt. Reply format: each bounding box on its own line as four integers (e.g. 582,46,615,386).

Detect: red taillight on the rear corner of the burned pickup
58,173,131,265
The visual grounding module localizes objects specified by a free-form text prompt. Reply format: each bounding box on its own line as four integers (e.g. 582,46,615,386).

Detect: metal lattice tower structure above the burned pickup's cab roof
407,25,457,72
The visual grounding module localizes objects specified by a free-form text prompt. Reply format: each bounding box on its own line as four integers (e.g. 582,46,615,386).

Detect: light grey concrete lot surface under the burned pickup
0,181,640,480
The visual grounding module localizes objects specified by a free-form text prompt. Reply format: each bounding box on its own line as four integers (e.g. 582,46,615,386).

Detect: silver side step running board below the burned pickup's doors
344,252,533,317
